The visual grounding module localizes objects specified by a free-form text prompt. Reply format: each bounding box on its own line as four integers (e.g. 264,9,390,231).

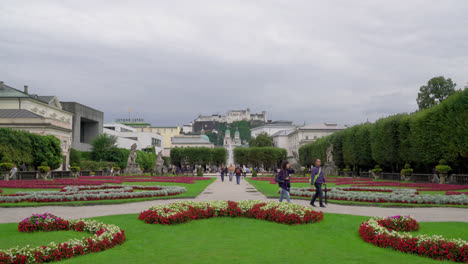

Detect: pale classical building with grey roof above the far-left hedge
0,82,73,170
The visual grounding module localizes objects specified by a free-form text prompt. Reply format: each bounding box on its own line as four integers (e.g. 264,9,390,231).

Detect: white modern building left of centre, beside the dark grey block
103,123,164,153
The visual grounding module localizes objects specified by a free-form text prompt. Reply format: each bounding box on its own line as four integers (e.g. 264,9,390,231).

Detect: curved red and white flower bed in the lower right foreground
359,216,468,263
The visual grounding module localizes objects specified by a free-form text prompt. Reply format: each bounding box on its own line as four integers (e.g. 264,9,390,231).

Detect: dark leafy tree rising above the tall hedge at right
416,76,457,110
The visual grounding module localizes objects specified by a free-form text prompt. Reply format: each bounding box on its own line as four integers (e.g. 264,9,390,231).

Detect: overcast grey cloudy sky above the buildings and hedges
0,0,468,125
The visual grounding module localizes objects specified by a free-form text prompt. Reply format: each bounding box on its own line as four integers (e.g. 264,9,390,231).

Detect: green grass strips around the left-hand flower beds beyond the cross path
0,178,215,207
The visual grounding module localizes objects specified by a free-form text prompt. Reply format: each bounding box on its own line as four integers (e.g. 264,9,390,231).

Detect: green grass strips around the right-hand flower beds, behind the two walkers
247,178,468,208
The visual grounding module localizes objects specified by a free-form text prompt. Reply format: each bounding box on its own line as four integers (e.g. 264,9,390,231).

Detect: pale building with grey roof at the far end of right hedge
273,123,346,163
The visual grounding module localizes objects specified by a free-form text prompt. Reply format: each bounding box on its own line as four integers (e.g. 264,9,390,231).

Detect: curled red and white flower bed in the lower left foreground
0,213,125,264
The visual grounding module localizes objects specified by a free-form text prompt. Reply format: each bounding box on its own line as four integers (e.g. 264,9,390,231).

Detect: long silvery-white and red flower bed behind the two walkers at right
291,187,468,205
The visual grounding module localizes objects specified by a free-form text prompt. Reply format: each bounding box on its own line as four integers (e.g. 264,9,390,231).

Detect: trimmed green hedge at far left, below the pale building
0,128,63,169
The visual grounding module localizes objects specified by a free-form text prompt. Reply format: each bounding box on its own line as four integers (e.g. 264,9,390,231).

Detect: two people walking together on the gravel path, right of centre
276,159,325,207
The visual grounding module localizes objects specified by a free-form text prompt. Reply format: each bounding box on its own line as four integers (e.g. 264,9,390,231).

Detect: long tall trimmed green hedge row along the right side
299,89,468,173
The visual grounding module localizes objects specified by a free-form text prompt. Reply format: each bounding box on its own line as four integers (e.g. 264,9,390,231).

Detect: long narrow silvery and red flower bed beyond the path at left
0,185,187,203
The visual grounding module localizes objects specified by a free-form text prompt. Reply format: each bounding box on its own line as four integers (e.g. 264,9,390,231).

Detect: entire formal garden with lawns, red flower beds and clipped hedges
0,87,468,264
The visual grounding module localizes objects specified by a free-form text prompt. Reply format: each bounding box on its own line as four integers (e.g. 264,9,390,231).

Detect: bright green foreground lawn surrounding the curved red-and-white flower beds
0,213,468,264
